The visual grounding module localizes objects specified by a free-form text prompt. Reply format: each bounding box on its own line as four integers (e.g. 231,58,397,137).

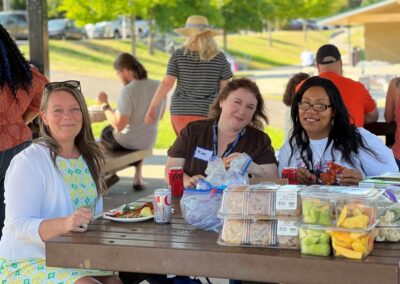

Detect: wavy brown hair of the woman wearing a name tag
208,78,268,131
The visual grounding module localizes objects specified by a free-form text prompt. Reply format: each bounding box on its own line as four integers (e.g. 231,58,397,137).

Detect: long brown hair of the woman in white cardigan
35,86,107,195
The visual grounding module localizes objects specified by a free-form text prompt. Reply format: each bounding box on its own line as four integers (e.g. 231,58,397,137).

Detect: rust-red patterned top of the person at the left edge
0,67,48,151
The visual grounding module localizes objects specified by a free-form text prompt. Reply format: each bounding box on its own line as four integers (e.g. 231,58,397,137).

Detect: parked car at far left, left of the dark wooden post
0,11,29,39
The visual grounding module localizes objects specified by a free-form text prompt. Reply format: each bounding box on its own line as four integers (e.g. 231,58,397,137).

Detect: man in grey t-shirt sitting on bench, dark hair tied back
97,53,166,190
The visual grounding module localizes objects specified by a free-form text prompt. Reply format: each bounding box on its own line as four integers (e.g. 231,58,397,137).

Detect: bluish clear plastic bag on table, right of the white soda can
181,189,223,232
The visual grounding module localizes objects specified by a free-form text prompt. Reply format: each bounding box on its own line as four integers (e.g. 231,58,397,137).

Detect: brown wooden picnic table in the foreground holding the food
46,196,400,284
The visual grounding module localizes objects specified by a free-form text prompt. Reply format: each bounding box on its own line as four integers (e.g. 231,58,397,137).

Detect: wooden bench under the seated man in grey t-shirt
102,147,153,187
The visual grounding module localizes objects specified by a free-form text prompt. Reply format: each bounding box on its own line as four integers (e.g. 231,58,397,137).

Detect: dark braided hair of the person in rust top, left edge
0,25,33,96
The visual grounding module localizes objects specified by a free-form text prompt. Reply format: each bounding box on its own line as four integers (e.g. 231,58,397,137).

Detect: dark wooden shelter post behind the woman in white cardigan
27,0,49,78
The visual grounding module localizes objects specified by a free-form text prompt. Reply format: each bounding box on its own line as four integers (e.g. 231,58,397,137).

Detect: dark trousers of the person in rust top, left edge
0,140,32,238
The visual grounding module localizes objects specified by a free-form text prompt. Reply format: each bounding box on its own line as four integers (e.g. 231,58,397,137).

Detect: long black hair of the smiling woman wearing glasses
289,76,377,172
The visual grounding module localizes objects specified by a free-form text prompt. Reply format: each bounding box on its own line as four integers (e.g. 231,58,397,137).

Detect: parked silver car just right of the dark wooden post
48,19,86,39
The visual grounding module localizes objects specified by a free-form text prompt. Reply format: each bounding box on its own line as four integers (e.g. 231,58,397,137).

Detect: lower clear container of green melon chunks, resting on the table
299,224,331,256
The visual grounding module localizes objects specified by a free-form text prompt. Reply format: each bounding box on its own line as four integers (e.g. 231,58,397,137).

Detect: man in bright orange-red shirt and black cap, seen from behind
317,44,379,127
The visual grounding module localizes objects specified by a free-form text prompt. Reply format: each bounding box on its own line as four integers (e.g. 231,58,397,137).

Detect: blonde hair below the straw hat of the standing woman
184,31,220,61
